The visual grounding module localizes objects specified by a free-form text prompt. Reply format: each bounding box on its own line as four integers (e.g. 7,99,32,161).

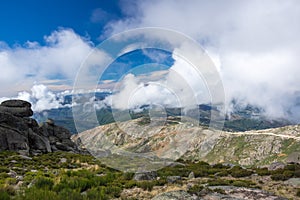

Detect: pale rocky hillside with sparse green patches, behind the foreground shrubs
72,115,300,166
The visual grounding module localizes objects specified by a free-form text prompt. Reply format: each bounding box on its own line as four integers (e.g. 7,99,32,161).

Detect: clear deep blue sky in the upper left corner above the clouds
0,0,122,46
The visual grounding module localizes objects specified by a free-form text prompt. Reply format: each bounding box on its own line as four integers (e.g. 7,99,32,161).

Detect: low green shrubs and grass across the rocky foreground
0,152,300,200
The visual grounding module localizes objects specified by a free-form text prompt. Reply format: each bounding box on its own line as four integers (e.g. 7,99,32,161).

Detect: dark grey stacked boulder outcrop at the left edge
0,100,78,154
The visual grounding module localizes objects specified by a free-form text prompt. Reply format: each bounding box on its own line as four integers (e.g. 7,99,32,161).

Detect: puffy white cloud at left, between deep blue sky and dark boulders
0,28,101,96
